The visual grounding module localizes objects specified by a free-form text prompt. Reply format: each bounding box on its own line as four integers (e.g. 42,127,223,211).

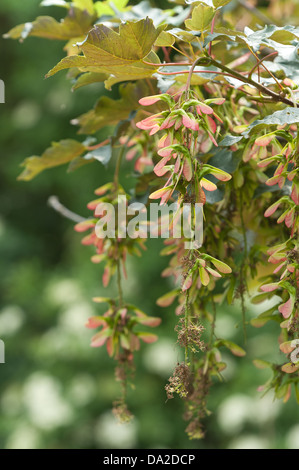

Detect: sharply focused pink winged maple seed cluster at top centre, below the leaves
136,93,227,204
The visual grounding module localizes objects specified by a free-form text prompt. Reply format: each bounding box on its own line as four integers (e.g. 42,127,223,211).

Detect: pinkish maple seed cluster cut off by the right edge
253,126,299,380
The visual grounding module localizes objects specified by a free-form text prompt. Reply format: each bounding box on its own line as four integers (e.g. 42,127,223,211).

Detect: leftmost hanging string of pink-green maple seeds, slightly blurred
75,183,161,362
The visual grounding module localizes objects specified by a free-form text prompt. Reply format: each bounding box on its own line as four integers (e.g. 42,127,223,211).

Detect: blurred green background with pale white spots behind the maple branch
0,0,299,449
